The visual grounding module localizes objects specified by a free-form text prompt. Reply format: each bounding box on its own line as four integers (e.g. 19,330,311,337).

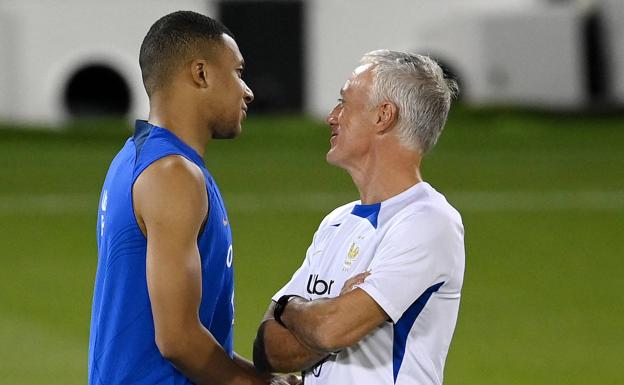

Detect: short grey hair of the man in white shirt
360,49,459,154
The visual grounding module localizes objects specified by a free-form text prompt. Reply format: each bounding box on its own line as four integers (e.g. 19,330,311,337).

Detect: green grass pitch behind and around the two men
0,109,624,385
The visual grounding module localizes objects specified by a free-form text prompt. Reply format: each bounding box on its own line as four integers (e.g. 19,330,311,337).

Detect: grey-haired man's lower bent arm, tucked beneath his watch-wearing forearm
254,302,327,373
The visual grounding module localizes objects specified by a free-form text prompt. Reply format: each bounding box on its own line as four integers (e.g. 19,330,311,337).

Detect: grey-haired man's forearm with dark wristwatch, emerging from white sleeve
281,288,388,353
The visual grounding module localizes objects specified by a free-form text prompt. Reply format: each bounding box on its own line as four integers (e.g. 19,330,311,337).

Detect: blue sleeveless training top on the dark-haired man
89,121,234,385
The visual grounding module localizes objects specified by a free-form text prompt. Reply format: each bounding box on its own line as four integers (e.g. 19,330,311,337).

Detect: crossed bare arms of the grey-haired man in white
254,273,388,372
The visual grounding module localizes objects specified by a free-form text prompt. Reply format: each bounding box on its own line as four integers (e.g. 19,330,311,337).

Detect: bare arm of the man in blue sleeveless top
133,156,268,385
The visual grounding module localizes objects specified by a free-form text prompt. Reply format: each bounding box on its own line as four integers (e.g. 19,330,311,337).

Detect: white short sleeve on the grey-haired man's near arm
358,210,463,322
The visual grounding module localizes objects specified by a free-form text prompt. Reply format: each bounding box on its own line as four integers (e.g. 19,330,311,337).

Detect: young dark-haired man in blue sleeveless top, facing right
89,11,294,385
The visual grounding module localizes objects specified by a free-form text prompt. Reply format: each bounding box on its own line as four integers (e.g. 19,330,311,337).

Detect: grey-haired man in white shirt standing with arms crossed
254,50,465,385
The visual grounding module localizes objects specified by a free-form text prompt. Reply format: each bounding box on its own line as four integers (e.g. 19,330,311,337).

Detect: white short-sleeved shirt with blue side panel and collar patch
273,182,465,385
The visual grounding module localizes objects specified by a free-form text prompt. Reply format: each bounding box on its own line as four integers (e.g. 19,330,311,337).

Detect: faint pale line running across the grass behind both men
0,191,624,215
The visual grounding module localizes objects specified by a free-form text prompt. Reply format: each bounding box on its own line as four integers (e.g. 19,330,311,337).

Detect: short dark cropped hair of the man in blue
139,11,234,96
